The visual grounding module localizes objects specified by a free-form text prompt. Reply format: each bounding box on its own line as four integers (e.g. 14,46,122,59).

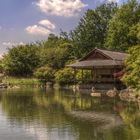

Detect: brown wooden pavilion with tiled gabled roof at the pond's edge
68,49,128,89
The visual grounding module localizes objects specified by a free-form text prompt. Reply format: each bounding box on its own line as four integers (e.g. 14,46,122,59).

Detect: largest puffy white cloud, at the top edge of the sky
36,0,87,17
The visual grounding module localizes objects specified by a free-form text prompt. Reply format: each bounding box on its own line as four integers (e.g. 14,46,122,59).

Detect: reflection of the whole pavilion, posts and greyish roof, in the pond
54,92,124,129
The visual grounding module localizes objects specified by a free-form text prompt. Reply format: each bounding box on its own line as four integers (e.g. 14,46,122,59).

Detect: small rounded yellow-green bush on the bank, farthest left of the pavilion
34,66,55,82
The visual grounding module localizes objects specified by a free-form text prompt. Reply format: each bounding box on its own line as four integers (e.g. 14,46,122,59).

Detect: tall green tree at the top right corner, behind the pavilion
106,0,140,51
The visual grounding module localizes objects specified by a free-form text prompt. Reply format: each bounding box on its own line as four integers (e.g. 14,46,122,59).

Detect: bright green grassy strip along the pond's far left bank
2,77,41,85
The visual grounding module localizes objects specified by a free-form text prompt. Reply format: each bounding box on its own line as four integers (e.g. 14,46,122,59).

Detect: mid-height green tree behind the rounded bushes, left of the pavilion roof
40,31,73,69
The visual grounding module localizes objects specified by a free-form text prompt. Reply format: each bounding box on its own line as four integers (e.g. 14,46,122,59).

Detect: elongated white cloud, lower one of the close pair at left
26,25,51,36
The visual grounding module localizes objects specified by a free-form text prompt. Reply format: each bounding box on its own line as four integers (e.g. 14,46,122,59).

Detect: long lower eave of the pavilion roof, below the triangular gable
68,60,123,68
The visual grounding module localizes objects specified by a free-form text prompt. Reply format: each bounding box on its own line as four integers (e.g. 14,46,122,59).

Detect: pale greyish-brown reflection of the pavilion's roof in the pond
69,111,124,129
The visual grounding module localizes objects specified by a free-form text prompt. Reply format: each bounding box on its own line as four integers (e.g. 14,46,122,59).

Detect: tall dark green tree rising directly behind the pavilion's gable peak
71,3,117,58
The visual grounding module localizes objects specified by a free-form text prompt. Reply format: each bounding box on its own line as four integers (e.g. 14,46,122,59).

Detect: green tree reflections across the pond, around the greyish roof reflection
1,90,140,140
